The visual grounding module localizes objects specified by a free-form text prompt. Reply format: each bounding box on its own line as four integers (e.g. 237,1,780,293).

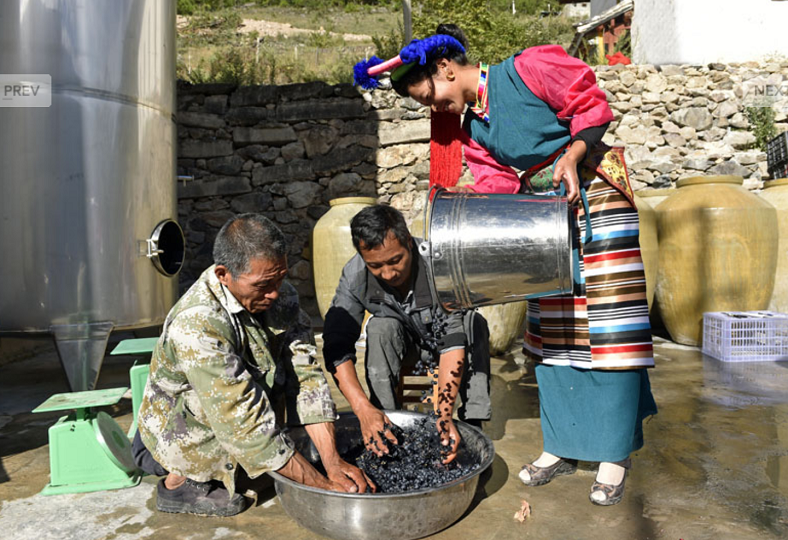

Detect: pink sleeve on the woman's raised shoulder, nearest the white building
514,45,613,137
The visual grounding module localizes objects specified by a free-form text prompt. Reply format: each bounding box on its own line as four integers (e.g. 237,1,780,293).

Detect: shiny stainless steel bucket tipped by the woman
420,190,573,311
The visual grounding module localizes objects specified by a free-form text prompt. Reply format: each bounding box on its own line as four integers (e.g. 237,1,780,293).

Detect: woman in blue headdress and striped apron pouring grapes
355,25,656,506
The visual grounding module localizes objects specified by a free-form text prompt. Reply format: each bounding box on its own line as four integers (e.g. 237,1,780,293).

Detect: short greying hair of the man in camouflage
213,214,287,279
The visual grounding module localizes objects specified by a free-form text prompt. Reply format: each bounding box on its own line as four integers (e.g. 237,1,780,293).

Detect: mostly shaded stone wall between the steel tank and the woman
177,82,430,314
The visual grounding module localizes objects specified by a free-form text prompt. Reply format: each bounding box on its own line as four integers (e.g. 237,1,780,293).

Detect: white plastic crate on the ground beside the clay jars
703,311,788,362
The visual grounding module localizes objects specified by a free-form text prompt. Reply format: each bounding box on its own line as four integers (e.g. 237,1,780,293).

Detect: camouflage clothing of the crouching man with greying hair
138,266,336,491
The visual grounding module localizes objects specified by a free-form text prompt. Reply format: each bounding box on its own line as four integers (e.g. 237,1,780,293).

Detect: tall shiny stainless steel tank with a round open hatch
0,0,184,390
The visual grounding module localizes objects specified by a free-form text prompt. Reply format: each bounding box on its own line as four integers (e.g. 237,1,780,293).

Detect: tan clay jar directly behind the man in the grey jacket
312,197,377,318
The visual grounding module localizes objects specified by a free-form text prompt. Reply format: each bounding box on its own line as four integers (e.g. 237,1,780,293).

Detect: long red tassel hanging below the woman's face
430,111,462,187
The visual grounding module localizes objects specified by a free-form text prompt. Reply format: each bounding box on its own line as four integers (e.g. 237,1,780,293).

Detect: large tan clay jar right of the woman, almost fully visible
656,176,777,345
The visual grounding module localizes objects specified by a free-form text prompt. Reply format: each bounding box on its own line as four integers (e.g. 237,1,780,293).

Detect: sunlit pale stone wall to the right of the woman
596,61,788,190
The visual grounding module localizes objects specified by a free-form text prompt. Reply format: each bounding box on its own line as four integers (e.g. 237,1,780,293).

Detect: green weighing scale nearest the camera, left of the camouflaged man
33,388,142,495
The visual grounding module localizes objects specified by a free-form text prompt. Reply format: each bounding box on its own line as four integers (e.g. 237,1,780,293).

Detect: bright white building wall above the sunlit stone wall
632,0,788,65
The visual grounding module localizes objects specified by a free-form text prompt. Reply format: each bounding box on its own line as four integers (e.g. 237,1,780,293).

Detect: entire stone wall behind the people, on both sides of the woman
178,62,788,314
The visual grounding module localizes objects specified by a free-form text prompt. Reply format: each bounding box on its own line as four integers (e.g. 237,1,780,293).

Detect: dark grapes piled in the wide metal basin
352,415,479,493
